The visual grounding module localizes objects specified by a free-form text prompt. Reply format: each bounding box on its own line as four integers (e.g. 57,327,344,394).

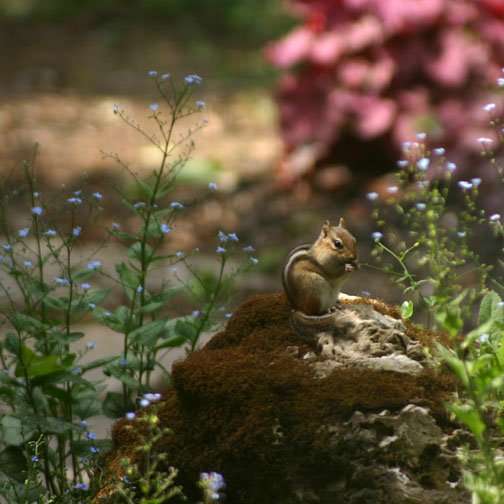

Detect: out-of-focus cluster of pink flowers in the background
266,0,504,183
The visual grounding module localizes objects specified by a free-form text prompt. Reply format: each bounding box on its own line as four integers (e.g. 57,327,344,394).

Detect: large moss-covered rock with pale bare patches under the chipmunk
95,294,470,504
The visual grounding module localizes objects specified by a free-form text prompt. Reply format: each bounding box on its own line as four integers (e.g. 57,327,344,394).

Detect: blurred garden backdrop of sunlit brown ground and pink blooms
0,0,504,318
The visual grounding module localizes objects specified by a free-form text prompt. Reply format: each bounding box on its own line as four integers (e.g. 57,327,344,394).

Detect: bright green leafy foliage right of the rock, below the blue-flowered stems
438,291,504,504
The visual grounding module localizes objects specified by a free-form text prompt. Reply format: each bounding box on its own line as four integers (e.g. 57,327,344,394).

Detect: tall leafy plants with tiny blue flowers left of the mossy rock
0,71,257,502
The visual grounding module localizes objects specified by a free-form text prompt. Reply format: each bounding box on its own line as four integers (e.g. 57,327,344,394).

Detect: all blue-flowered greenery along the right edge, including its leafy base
368,77,504,504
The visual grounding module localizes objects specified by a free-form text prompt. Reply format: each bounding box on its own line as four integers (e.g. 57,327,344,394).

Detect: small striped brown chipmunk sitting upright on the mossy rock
282,218,358,318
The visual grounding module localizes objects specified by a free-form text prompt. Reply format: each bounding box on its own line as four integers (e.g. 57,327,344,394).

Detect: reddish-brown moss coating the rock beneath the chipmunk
99,294,453,504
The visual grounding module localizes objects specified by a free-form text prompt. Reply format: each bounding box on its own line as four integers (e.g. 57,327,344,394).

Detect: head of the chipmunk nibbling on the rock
317,218,358,273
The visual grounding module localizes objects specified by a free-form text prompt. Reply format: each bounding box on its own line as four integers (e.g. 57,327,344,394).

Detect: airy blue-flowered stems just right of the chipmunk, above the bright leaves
368,135,489,335
